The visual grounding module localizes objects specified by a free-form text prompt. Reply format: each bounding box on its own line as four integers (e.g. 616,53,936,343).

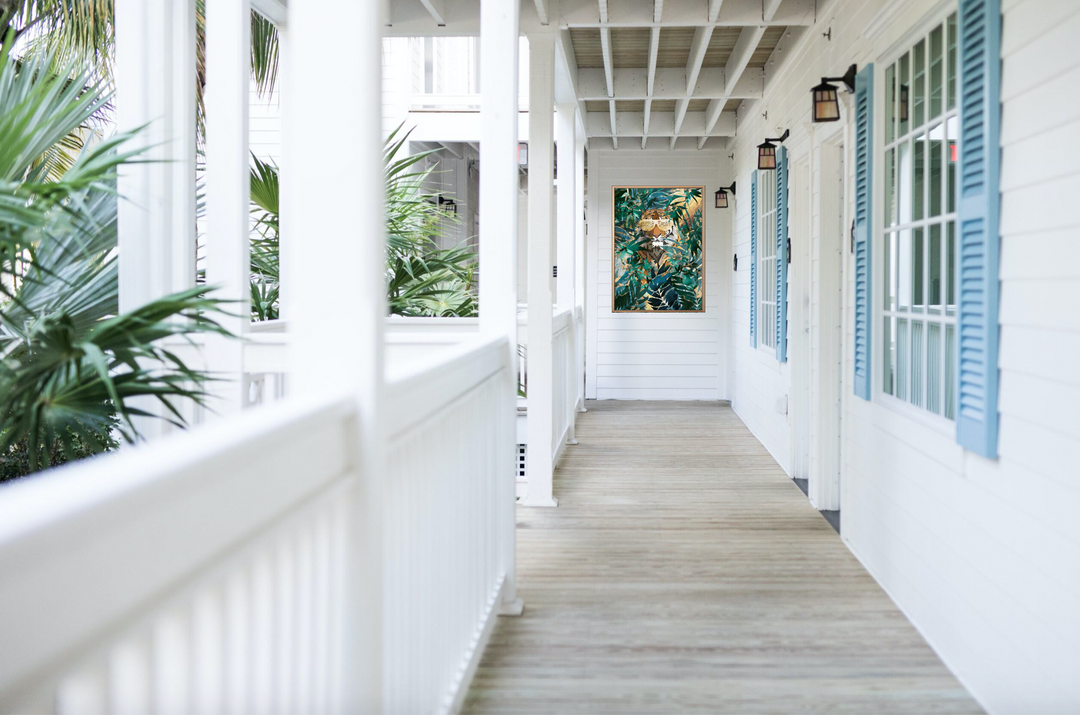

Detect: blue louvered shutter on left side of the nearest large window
854,65,874,400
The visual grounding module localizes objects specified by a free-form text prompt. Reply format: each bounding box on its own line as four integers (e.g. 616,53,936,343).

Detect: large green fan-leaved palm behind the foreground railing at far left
0,43,233,476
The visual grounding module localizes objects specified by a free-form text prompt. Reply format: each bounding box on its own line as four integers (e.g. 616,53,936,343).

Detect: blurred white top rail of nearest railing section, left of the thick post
0,399,355,692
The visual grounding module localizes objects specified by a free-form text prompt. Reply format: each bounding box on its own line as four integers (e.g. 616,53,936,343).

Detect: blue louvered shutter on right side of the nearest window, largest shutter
956,0,1001,459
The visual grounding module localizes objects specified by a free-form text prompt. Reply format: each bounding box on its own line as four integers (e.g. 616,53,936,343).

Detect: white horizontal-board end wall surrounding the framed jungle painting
585,147,731,400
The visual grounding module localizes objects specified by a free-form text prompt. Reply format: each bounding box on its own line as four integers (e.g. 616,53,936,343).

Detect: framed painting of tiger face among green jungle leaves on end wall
611,186,705,312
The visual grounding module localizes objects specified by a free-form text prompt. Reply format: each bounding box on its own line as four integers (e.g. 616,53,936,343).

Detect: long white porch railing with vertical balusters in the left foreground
0,339,514,713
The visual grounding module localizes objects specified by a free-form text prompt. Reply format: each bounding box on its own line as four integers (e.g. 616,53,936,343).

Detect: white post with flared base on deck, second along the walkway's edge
522,33,558,507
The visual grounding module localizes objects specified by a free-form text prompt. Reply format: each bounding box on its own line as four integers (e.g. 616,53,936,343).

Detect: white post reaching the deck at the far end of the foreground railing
480,0,523,615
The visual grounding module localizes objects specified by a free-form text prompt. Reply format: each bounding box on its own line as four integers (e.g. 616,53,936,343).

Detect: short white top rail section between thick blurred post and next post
387,336,509,439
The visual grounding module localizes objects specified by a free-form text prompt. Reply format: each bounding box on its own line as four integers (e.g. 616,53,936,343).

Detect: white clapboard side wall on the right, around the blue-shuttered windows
725,0,1080,714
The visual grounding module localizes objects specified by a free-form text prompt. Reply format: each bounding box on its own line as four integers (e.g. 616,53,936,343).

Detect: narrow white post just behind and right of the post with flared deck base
554,104,579,444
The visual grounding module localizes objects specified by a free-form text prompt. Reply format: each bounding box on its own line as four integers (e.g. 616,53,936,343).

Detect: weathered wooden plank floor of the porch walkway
464,402,982,714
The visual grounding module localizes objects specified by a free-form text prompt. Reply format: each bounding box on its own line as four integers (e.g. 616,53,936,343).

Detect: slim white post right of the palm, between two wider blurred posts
204,0,252,416
